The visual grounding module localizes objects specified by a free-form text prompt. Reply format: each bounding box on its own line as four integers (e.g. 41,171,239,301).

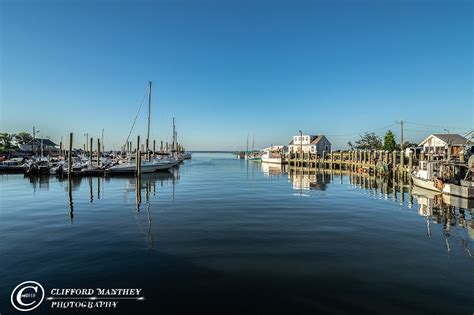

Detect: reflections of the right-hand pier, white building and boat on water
288,168,474,257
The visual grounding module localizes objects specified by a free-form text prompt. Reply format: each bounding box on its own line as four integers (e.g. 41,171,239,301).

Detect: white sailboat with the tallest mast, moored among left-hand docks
108,81,178,174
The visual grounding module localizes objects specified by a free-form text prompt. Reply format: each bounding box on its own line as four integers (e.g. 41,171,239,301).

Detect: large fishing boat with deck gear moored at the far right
411,161,474,198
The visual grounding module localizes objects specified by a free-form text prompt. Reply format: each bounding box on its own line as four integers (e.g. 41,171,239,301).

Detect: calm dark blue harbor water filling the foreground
0,153,474,314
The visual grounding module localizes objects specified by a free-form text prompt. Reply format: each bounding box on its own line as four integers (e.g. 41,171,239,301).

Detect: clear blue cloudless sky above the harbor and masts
0,0,474,150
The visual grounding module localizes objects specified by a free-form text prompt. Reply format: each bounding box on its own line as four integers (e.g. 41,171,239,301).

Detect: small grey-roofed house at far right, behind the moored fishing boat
419,133,471,155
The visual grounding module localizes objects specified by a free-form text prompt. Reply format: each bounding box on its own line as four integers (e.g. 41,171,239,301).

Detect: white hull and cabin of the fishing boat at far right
411,161,474,198
